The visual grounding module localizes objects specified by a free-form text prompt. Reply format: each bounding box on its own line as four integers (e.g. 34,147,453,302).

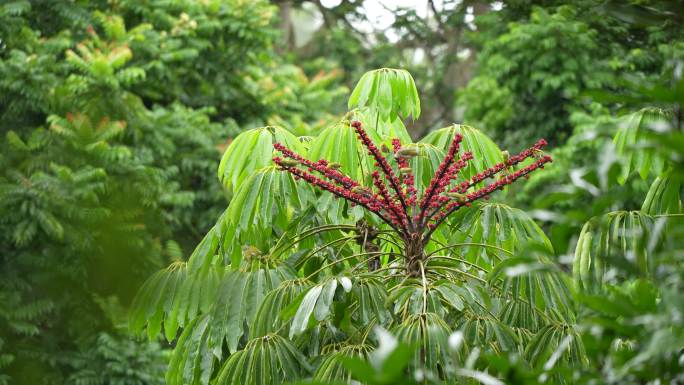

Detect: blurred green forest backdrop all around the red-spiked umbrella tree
0,0,684,384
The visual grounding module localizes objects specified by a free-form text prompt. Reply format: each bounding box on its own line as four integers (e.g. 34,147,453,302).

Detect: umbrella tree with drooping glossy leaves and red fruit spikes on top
131,68,584,385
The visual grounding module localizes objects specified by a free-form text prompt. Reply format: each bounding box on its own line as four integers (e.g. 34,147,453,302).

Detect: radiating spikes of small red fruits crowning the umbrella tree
273,121,552,240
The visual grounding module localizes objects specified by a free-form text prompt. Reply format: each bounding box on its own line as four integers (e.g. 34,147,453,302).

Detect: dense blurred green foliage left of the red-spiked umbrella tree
0,1,344,384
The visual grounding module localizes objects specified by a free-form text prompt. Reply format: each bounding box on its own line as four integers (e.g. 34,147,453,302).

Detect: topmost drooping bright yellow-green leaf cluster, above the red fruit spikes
348,68,420,120
